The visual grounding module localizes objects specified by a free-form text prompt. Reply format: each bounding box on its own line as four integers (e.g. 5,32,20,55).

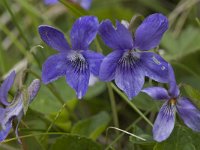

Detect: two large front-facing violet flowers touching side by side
39,14,168,99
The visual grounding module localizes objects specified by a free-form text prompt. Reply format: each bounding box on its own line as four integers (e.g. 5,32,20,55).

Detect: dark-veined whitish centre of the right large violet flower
118,50,140,68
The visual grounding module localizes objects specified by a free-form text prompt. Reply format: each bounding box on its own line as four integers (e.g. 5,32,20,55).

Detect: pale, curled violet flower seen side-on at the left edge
0,71,40,142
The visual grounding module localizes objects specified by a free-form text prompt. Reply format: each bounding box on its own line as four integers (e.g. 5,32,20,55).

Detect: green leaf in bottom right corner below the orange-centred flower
154,125,200,150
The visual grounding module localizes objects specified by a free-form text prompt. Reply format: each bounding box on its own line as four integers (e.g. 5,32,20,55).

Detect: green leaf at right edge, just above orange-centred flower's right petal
183,84,200,108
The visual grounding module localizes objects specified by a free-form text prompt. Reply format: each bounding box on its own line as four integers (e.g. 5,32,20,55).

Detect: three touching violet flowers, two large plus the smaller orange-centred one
39,13,200,142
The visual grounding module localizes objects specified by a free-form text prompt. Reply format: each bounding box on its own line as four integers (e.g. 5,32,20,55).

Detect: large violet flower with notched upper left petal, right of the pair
99,13,168,99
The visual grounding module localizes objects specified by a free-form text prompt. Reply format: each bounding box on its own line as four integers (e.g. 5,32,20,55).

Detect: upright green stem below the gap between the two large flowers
107,83,119,128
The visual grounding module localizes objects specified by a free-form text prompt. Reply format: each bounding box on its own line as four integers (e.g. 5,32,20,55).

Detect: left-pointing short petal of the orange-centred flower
142,87,170,100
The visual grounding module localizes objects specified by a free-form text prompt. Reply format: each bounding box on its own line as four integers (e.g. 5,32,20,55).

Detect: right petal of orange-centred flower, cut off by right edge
177,97,200,132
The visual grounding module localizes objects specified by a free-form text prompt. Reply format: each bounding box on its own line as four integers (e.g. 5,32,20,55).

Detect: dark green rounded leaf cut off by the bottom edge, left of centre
51,135,102,150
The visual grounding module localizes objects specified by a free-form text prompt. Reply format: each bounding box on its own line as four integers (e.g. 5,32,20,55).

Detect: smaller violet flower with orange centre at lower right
142,65,200,142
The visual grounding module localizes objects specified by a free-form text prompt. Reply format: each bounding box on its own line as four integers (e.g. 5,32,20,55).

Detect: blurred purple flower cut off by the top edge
44,0,92,10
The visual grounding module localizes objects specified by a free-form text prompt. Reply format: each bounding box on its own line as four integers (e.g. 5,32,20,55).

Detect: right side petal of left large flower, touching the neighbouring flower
83,50,104,76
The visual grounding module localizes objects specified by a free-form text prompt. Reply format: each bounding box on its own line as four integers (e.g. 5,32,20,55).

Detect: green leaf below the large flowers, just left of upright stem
71,112,110,139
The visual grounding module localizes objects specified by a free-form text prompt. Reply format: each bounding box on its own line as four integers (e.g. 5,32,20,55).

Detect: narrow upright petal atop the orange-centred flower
168,64,180,97
